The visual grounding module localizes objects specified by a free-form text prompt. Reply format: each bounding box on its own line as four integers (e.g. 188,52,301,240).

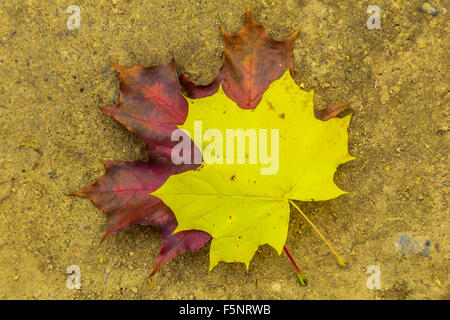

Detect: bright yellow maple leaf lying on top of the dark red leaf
152,71,353,269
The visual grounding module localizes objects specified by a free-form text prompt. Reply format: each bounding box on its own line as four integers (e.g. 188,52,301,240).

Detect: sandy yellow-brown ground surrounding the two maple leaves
0,0,450,299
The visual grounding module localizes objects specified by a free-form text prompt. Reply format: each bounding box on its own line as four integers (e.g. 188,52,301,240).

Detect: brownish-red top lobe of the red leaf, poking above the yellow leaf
181,7,300,109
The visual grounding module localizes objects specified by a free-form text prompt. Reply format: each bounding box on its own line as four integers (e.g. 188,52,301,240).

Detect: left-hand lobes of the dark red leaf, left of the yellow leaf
74,61,210,274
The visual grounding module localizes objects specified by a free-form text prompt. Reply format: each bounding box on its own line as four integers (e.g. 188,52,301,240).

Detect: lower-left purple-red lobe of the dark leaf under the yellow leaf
75,160,210,273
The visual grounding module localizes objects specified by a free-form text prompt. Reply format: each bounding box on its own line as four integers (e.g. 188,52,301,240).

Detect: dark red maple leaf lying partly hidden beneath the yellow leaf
75,9,347,274
